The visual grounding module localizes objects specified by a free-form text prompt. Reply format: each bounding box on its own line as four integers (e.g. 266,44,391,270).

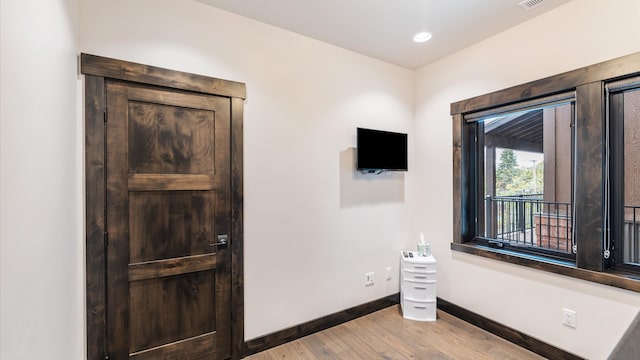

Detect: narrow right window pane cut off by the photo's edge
605,78,640,271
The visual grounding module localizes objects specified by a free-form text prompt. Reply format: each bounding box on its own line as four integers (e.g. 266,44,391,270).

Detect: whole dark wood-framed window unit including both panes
451,53,640,292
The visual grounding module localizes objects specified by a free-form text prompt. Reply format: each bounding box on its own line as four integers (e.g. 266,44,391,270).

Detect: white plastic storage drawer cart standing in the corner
400,251,436,321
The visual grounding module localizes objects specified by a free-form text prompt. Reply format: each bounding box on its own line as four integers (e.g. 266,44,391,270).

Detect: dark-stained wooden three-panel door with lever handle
106,81,231,360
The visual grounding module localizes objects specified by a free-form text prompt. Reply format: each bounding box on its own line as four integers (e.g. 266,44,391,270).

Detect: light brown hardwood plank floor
246,306,544,360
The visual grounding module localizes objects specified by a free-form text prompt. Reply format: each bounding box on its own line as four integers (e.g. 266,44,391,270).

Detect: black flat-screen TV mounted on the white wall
356,128,407,171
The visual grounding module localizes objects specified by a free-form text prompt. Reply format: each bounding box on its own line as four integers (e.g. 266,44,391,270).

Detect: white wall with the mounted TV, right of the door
81,0,417,339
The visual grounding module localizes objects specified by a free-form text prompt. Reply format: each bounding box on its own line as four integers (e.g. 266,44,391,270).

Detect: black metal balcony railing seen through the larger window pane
485,194,572,254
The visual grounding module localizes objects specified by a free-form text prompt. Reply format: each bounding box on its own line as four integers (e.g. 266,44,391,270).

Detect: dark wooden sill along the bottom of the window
451,243,640,292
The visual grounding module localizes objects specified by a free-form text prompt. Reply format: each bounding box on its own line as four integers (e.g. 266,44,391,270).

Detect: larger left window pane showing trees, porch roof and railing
464,100,575,259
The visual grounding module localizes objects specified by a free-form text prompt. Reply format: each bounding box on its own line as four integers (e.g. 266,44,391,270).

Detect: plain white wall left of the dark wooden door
0,0,84,360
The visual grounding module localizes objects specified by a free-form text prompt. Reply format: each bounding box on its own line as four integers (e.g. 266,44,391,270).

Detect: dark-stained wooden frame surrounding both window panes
451,53,640,292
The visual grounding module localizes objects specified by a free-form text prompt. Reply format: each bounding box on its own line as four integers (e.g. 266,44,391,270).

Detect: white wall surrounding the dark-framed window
414,0,640,359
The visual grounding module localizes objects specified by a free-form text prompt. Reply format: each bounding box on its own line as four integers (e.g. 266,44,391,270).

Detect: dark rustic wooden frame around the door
80,54,246,360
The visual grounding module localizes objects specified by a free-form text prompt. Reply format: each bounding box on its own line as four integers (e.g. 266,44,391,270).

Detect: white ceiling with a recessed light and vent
197,0,571,69
